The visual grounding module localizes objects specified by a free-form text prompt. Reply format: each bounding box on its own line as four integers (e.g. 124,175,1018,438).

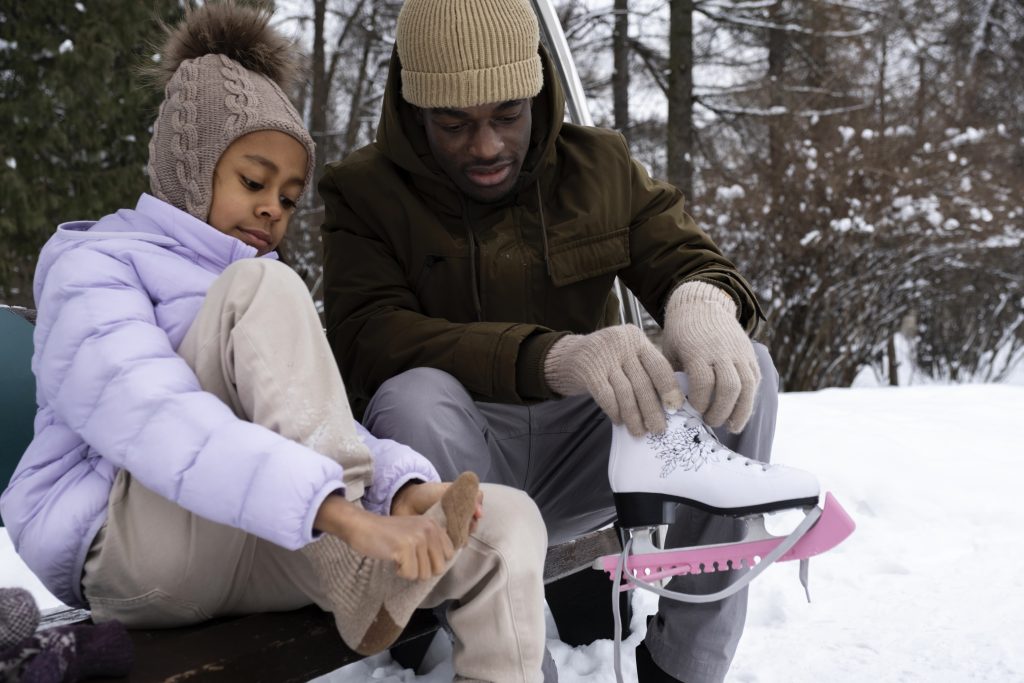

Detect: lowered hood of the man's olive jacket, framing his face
374,46,565,214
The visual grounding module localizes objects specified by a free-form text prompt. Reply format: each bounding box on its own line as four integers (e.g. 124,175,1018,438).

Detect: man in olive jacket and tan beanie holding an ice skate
319,0,777,683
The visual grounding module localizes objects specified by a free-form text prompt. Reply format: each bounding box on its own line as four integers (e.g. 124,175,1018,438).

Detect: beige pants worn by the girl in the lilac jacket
82,259,547,682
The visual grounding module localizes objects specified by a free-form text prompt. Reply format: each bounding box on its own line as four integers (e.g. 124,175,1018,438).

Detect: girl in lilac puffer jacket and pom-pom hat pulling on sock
0,3,547,681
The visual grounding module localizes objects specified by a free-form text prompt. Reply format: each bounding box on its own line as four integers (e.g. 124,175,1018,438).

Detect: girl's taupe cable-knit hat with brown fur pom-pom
148,1,315,221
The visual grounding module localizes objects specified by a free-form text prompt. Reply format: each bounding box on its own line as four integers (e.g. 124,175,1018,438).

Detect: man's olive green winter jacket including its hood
318,50,760,416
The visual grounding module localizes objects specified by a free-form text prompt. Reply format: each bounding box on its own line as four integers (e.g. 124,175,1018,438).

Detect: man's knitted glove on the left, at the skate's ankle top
544,325,683,436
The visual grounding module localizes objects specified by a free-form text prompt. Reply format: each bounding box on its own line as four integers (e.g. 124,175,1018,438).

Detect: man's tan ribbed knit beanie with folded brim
395,0,544,109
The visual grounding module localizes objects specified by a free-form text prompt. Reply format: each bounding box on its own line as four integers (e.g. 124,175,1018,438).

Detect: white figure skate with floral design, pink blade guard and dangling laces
594,401,854,683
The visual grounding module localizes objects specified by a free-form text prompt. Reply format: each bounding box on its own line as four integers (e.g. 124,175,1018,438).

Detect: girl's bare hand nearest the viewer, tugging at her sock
313,496,455,581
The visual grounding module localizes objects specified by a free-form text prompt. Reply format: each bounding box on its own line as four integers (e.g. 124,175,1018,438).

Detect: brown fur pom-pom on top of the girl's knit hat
153,0,298,92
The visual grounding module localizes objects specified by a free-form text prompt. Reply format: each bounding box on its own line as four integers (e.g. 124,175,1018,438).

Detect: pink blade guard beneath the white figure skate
593,493,856,590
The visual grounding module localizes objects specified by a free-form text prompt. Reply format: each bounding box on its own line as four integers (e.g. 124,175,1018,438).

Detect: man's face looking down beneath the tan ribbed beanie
420,99,532,204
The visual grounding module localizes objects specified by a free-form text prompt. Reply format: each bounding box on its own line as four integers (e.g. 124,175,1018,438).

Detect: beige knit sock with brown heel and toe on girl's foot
302,472,479,655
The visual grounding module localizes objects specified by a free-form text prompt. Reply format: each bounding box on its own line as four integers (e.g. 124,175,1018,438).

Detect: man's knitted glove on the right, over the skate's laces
663,282,761,433
